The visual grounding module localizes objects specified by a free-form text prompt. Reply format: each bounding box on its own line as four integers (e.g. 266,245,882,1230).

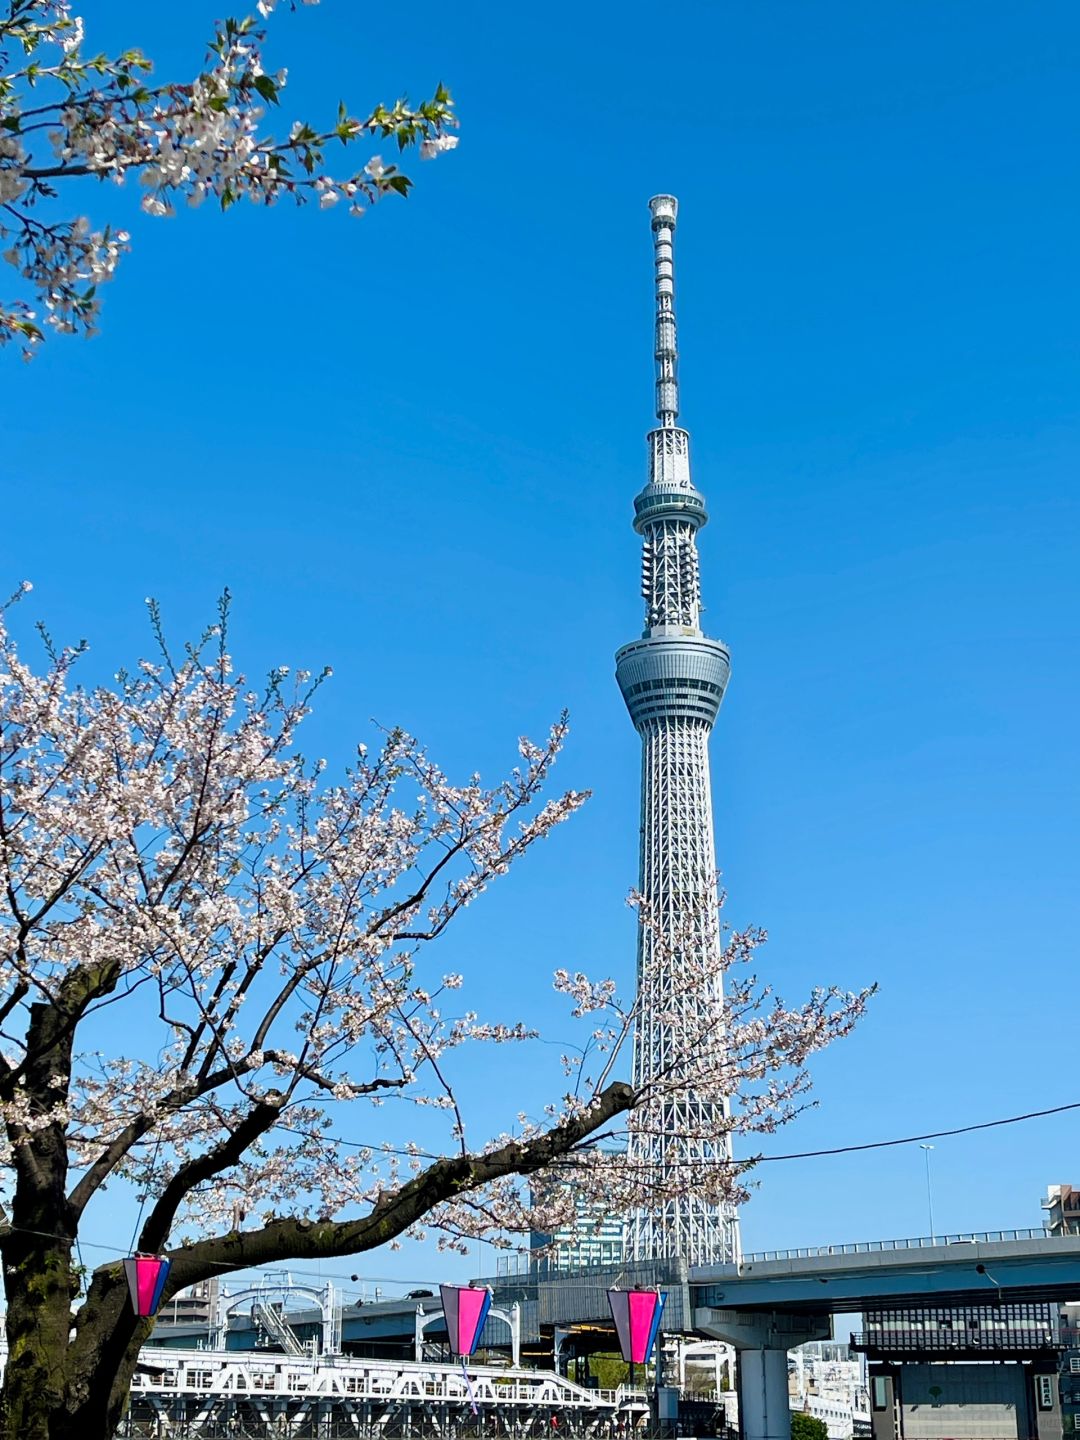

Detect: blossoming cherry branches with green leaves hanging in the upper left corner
0,0,456,359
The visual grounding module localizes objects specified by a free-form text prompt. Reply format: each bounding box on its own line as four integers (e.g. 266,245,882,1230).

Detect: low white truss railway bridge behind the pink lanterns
120,1346,648,1440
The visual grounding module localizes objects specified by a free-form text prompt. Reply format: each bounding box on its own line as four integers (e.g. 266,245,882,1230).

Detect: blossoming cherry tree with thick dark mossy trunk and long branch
0,587,865,1440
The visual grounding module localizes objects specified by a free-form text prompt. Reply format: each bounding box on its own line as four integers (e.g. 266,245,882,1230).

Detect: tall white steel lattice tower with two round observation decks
615,194,739,1264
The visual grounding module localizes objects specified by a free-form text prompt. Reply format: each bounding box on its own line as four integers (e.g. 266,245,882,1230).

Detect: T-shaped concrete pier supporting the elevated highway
694,1309,832,1440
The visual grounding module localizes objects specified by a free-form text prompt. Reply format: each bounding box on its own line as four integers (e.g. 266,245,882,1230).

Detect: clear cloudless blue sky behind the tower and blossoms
0,0,1080,1277
